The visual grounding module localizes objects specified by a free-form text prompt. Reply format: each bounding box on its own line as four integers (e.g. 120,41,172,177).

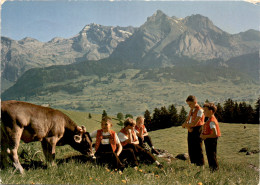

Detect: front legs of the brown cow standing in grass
42,137,58,166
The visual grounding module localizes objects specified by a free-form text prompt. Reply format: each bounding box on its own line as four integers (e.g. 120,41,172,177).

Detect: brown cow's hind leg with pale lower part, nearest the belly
7,124,24,174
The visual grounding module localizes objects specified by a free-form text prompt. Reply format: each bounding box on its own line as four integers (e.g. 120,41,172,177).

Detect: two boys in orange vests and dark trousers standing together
182,95,221,171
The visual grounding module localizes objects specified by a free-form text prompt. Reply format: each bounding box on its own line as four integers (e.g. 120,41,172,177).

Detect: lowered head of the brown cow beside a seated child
72,126,94,157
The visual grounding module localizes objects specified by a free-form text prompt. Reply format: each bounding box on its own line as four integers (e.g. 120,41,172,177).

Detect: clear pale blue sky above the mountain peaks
1,0,260,42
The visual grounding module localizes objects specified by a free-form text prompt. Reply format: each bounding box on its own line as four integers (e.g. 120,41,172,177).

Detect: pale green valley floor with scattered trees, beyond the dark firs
10,69,259,115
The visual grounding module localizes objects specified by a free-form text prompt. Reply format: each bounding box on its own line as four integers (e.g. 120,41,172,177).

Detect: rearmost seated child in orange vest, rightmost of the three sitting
135,116,159,155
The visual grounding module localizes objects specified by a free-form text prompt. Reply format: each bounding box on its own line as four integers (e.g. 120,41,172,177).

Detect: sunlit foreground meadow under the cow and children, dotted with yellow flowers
1,110,259,185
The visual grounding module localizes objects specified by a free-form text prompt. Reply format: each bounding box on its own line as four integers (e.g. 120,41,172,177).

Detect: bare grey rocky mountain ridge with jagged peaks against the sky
1,10,260,90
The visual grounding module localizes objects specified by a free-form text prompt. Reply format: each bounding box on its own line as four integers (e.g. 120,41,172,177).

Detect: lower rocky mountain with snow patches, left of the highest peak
1,24,135,82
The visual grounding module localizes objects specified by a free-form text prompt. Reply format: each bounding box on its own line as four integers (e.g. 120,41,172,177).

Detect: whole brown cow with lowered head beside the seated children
1,100,93,173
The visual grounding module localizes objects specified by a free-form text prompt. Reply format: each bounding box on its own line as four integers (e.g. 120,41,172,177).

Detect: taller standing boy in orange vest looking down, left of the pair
182,95,204,166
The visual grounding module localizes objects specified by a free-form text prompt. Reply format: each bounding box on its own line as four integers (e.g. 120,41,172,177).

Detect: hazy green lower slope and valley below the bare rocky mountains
2,53,259,114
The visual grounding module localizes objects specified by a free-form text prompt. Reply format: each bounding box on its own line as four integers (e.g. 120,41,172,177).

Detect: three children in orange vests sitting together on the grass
90,116,162,170
